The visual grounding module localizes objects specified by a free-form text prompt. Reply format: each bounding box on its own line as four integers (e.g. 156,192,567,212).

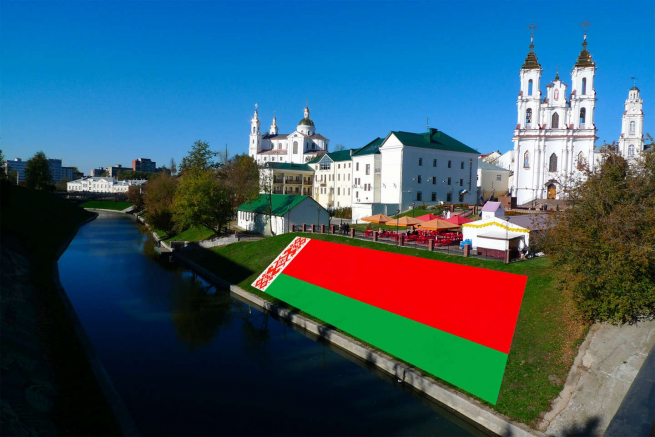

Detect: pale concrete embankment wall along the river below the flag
173,251,544,437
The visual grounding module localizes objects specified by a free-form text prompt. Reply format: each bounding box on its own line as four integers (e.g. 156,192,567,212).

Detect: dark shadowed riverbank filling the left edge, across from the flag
0,181,123,435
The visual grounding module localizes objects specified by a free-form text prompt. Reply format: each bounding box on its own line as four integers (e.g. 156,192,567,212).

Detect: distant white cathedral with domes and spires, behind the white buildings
248,105,330,165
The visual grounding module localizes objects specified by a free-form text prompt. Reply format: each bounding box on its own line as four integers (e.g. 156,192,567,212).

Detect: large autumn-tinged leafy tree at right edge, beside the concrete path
545,146,655,322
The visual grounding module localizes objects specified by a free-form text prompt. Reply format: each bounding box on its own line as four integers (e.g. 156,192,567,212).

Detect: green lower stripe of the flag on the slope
266,274,507,404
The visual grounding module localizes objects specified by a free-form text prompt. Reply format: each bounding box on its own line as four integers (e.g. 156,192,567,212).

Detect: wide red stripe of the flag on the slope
284,240,527,354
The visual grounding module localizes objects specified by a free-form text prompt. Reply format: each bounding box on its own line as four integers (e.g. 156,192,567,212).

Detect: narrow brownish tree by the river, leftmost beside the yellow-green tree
143,173,177,234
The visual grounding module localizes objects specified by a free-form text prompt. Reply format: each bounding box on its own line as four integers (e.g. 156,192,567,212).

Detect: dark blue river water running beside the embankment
59,213,481,436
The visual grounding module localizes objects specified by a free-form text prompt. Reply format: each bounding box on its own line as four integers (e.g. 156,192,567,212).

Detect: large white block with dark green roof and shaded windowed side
380,129,480,211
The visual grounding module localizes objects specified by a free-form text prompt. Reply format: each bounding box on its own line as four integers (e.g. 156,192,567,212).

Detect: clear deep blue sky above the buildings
0,0,655,173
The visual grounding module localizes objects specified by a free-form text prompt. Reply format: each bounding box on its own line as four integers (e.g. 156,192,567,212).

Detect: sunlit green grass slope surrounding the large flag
184,232,588,425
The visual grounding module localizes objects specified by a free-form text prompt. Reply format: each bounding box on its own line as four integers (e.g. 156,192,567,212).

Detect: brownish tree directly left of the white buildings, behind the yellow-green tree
221,154,259,208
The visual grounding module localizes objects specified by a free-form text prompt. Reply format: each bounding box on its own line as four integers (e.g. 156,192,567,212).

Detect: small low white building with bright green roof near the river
237,194,330,235
